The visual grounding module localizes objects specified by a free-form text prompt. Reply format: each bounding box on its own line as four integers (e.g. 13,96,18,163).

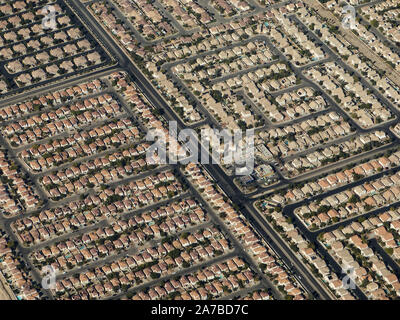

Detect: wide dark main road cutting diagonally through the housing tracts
66,0,332,300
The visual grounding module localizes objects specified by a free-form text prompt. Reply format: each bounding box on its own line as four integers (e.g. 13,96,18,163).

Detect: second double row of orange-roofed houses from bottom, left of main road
51,228,230,299
